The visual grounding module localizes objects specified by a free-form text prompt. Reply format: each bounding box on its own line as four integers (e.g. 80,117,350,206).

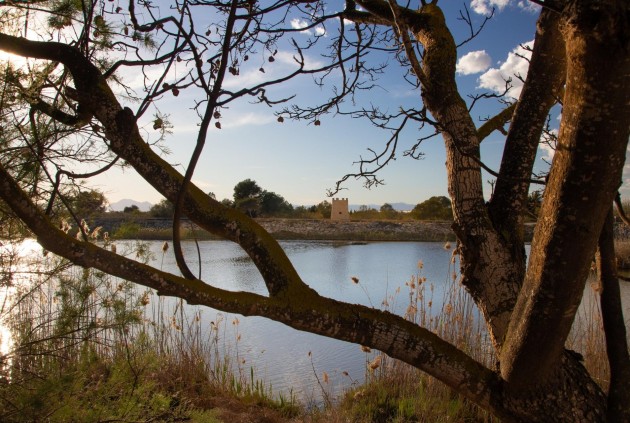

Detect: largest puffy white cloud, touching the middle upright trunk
479,41,534,99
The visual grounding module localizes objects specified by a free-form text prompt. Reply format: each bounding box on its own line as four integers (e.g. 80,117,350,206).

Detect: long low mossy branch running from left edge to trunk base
0,160,506,414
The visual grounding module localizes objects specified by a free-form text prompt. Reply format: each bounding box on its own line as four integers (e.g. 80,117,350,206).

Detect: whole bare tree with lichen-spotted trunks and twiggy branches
0,0,630,422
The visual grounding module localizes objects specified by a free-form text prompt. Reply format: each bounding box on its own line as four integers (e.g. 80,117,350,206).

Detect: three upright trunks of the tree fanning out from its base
415,0,628,421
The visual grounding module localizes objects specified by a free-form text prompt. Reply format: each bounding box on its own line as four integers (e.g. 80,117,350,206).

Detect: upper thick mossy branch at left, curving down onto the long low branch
0,34,303,295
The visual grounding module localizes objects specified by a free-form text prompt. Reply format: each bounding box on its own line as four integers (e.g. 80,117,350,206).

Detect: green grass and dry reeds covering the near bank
0,240,608,423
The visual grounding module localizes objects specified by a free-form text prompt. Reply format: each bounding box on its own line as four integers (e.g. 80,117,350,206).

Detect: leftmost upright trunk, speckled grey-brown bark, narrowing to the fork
409,4,518,347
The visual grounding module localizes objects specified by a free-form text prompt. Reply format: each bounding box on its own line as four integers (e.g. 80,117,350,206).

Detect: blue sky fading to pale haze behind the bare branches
91,0,556,209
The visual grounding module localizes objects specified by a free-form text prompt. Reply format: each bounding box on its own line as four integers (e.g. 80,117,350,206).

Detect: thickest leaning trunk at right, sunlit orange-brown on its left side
501,0,630,389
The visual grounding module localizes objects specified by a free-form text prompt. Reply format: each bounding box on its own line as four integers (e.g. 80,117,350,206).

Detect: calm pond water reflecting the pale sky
0,241,630,401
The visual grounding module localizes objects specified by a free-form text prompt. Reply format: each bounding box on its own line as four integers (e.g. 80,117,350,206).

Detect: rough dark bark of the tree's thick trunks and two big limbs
0,0,630,422
